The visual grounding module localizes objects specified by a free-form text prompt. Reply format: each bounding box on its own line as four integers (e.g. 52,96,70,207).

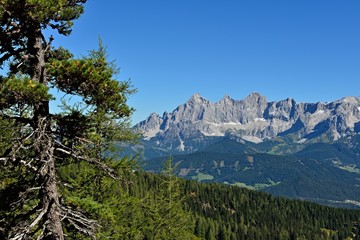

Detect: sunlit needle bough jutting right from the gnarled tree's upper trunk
47,41,133,117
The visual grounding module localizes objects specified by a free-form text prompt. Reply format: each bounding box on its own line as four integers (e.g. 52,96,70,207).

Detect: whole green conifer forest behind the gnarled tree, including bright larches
0,158,360,240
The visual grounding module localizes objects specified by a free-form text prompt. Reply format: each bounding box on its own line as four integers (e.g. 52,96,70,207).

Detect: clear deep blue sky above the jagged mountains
50,0,360,123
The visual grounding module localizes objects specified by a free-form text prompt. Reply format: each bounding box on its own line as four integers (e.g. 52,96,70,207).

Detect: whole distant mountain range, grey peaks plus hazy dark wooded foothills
132,93,360,207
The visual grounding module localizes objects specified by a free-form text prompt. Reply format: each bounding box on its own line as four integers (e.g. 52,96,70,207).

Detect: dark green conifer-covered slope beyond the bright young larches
131,169,360,239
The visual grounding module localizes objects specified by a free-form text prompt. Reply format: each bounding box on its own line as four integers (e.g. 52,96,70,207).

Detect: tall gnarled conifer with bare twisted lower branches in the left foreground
0,0,134,240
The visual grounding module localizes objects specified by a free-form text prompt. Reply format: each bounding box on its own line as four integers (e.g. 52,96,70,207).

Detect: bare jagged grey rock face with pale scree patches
134,93,360,152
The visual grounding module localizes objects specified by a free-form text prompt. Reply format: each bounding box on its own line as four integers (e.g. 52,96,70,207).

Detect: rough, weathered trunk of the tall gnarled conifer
32,30,64,240
